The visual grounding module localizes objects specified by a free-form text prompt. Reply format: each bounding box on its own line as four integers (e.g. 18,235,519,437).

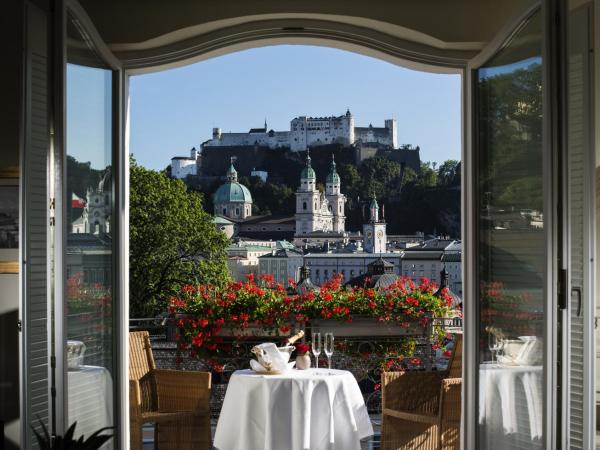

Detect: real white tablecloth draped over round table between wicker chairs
214,369,373,450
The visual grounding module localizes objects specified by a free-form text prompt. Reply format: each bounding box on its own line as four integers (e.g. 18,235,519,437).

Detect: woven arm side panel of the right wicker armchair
381,371,444,415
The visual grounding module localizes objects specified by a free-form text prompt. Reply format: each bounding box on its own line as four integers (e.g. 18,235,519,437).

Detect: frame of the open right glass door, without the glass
461,0,562,450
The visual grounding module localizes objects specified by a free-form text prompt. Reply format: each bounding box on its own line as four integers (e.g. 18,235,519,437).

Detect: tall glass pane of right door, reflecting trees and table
476,12,546,450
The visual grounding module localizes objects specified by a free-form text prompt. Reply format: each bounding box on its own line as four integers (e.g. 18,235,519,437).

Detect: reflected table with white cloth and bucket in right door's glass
479,332,543,448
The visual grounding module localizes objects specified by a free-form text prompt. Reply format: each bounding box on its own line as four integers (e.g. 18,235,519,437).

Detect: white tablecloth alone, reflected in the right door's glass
479,364,543,448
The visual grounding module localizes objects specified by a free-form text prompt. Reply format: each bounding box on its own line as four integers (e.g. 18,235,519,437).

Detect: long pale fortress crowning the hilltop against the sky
202,110,398,151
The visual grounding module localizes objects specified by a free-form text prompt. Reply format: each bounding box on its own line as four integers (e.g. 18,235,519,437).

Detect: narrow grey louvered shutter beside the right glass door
566,7,595,450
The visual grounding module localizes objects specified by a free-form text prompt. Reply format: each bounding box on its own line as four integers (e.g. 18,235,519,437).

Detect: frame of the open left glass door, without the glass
48,0,129,442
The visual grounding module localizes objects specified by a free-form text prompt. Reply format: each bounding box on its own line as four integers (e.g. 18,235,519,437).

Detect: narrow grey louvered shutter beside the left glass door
21,4,50,449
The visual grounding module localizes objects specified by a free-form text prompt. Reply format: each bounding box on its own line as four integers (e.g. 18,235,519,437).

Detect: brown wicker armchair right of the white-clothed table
381,335,462,450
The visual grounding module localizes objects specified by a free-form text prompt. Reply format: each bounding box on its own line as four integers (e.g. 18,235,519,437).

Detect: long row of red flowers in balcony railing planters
169,274,449,356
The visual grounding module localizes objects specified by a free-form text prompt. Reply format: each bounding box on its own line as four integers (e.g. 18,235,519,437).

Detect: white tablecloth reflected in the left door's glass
68,366,114,449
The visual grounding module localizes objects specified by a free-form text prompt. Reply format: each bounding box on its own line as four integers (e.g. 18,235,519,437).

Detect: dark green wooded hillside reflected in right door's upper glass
478,63,543,211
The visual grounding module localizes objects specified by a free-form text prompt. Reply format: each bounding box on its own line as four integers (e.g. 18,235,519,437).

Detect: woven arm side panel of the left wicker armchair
152,369,211,413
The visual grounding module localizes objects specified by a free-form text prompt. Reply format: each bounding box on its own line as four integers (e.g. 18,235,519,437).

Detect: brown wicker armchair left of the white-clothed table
129,331,212,450
